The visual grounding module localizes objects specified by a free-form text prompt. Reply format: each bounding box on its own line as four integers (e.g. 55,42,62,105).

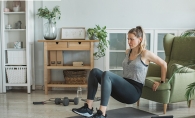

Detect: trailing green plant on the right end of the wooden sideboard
87,25,109,59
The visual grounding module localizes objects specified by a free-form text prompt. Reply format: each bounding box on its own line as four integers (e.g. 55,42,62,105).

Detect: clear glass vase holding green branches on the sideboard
44,19,57,40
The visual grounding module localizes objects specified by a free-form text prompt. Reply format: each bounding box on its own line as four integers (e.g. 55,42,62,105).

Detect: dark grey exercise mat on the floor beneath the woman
68,107,156,118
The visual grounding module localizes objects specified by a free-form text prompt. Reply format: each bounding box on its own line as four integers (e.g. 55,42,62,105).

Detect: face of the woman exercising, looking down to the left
128,33,141,49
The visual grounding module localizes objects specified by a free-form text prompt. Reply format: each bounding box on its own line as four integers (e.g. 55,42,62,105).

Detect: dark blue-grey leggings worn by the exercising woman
87,68,143,106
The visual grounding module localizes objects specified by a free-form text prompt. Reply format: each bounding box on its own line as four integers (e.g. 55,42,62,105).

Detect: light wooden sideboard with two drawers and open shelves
38,40,98,94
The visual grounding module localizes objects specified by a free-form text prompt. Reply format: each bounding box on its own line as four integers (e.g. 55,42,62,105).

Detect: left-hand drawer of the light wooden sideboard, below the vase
47,41,67,50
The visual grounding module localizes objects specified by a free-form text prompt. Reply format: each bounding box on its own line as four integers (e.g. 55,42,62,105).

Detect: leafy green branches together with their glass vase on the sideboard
36,6,61,40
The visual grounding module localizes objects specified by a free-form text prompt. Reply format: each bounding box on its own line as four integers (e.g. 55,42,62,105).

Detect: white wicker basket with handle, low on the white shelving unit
5,66,26,84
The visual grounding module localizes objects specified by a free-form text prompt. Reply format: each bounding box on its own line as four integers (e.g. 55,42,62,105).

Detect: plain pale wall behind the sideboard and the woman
34,0,195,85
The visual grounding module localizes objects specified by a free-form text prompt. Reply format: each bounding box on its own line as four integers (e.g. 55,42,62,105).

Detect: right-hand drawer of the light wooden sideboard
68,42,90,50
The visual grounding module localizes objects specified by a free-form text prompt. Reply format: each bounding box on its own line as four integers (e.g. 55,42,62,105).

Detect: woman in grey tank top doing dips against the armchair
72,26,167,118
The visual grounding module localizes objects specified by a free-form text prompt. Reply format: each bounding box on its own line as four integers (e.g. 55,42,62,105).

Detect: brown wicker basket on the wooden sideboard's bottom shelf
63,70,87,84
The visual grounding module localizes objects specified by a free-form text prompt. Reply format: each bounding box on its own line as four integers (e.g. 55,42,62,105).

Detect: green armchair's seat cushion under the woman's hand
144,77,171,90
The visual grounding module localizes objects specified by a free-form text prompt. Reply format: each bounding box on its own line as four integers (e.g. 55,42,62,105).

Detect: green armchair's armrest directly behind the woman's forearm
147,63,161,77
